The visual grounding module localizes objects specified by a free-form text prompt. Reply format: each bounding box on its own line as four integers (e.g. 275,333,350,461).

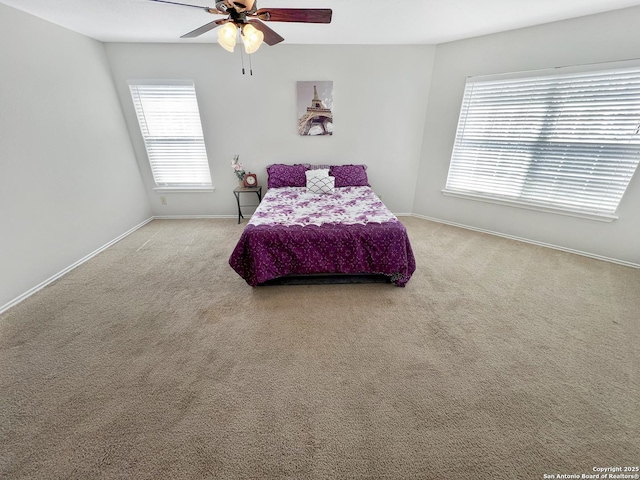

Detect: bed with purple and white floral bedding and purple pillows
229,164,415,287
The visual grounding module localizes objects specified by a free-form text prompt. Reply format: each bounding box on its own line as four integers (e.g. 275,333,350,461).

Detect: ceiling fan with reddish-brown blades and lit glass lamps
151,0,332,53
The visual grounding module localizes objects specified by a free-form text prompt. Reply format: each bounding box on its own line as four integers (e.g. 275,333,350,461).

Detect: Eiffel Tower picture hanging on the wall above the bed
298,81,333,136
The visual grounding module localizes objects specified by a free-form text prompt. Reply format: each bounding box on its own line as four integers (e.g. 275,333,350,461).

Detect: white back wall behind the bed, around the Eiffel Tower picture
106,43,435,215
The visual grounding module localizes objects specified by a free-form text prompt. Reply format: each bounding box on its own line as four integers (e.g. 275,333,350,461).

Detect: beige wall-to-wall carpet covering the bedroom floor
0,218,640,480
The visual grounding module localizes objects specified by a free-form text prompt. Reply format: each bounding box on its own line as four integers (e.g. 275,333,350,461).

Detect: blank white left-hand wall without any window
0,4,151,308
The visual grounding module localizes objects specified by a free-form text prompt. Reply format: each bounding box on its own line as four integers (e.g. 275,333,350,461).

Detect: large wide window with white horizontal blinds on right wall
443,62,640,220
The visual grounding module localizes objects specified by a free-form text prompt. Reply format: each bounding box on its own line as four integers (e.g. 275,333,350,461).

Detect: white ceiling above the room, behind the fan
0,0,640,45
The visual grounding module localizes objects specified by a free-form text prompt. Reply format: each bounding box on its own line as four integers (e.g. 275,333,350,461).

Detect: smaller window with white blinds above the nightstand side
129,82,211,189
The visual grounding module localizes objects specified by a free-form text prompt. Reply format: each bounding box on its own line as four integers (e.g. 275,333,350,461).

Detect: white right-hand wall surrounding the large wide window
413,7,640,264
